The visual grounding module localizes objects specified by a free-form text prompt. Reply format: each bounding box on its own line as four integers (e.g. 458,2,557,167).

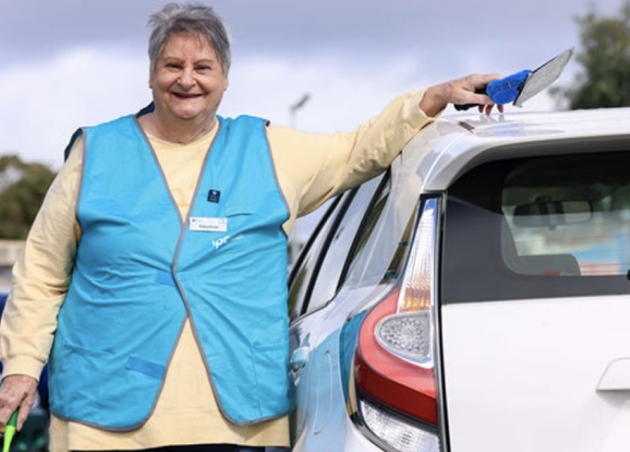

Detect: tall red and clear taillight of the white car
354,198,440,452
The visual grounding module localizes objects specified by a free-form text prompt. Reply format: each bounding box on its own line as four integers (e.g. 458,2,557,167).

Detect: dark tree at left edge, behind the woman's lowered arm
0,155,55,239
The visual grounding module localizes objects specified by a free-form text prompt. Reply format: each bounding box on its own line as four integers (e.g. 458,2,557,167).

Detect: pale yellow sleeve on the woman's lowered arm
0,139,83,379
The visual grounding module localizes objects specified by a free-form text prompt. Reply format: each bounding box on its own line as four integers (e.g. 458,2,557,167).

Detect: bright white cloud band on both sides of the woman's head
0,43,564,168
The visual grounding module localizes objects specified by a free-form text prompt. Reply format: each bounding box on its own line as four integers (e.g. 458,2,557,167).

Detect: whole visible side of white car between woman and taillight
289,150,432,452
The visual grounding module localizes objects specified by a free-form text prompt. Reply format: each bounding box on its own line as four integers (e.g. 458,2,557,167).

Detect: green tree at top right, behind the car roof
550,0,630,110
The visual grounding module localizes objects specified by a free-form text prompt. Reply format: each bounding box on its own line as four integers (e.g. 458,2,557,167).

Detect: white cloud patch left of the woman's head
0,48,150,168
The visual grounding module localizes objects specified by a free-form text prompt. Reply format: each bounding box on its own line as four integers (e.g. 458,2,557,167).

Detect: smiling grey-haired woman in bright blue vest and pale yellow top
0,4,504,451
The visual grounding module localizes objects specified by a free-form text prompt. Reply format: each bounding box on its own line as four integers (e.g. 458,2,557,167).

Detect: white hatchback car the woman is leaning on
289,108,630,452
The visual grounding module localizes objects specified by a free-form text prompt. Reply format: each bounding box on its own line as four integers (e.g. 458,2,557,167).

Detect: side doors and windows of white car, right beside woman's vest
289,174,383,451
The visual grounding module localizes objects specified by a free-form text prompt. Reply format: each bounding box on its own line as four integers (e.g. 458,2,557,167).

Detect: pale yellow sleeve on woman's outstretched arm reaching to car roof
267,91,434,223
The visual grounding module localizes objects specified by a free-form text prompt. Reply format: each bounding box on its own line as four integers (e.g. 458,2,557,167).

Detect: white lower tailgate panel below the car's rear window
442,295,630,452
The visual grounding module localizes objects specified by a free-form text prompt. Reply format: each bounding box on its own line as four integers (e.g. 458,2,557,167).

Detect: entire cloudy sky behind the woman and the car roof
0,0,624,170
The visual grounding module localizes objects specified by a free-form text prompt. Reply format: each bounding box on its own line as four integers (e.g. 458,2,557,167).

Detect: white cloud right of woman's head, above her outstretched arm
223,57,436,132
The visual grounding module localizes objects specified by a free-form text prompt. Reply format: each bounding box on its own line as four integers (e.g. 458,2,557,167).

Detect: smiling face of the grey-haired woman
149,33,228,130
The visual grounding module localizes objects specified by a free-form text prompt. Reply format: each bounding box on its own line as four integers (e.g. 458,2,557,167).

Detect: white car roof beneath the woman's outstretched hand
403,108,630,192
